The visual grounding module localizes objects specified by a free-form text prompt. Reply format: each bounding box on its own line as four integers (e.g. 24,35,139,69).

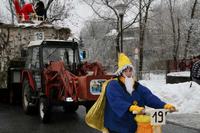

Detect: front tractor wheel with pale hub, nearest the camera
39,97,51,123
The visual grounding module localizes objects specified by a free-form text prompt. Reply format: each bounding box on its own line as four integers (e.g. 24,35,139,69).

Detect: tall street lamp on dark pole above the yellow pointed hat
114,1,127,52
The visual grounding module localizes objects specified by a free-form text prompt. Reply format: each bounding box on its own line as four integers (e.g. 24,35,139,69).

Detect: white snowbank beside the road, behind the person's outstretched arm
139,75,200,114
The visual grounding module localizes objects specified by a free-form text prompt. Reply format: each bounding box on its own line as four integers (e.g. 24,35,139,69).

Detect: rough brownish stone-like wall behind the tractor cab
0,23,70,88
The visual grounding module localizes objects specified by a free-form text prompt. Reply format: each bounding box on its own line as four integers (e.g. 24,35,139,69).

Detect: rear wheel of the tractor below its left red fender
22,79,33,114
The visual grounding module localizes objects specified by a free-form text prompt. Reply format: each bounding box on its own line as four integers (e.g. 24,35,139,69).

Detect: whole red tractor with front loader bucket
21,40,112,123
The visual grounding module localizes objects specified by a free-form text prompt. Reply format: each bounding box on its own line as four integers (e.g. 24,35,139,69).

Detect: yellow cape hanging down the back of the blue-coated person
85,80,110,133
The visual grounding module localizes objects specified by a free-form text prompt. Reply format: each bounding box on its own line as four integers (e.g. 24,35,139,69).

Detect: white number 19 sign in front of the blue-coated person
151,109,166,125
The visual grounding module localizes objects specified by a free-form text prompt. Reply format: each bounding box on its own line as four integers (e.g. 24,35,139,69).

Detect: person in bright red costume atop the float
14,0,35,21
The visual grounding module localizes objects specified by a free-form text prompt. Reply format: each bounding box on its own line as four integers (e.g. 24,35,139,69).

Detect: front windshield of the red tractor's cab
43,47,73,65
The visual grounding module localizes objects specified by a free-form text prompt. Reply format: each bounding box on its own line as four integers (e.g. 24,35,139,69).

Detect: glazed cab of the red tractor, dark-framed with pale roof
25,40,80,73
